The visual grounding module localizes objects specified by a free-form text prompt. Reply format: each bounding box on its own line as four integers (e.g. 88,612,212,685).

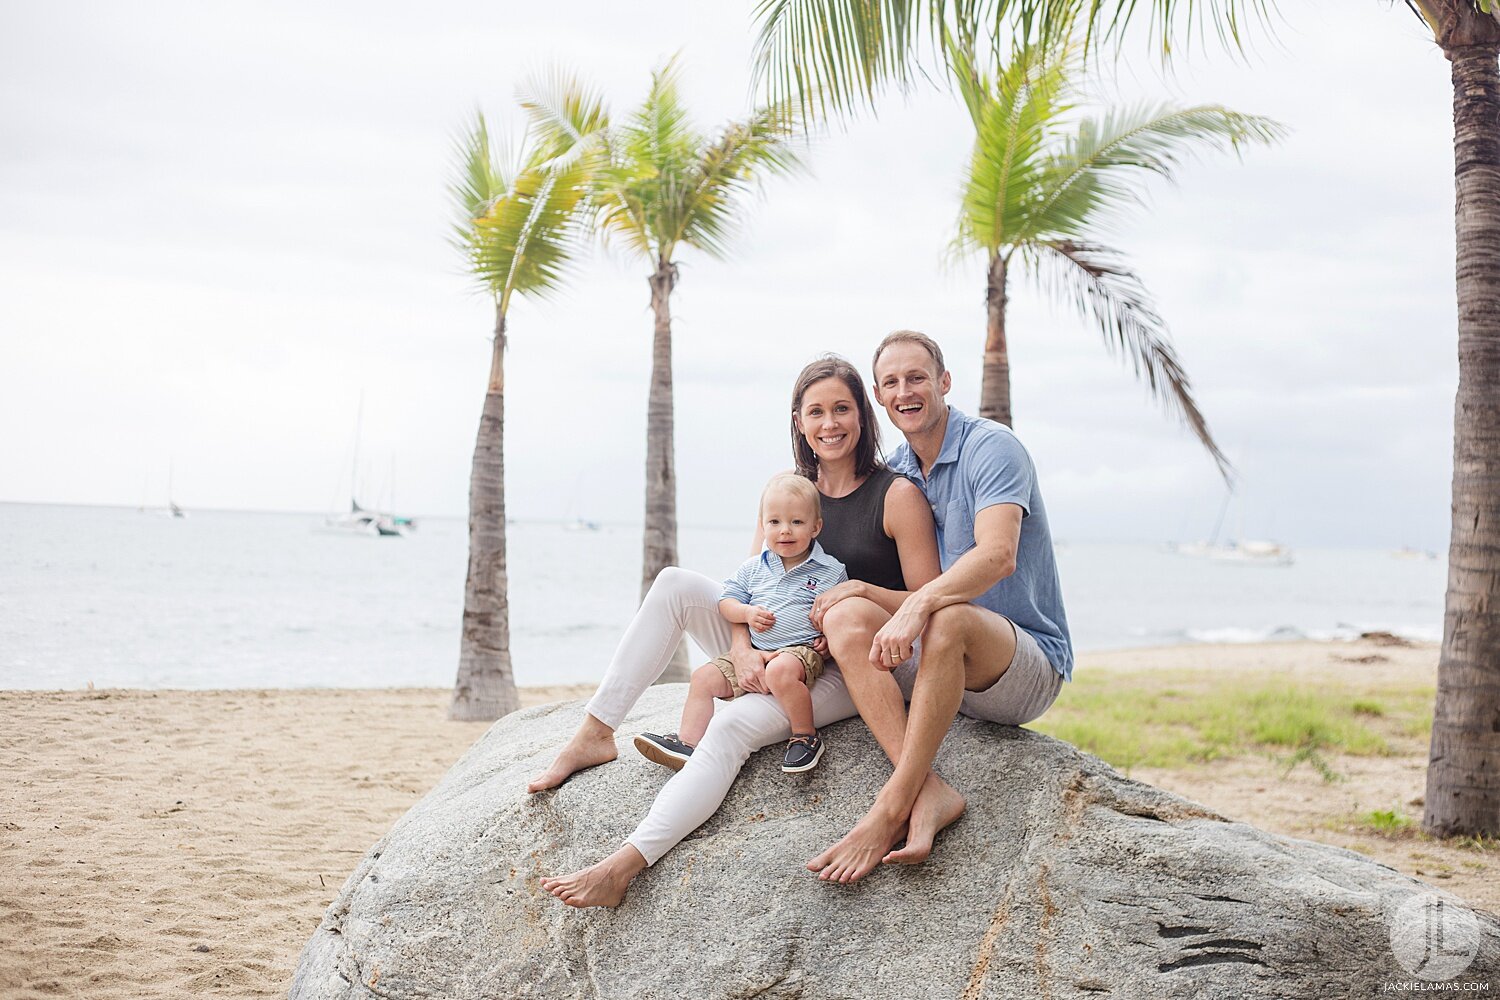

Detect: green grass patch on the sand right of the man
1031,672,1433,780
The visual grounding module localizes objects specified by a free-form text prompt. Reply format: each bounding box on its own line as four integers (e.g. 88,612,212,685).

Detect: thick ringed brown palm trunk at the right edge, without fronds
1422,35,1500,837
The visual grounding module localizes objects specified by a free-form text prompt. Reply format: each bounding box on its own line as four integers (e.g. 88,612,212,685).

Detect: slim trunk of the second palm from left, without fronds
641,256,689,684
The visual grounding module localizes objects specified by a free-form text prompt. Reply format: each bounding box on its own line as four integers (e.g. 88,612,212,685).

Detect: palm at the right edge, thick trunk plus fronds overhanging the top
756,0,1500,835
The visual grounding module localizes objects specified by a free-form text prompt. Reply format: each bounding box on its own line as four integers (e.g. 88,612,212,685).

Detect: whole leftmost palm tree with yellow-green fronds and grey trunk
449,79,606,720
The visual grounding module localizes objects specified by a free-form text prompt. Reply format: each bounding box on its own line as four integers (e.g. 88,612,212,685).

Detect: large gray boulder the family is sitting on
291,685,1500,1000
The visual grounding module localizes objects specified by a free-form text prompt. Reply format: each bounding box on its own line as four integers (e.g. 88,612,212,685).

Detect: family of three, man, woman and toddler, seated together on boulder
527,330,1073,907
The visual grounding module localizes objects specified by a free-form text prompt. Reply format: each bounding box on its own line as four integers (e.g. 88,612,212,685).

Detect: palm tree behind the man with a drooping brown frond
947,37,1281,478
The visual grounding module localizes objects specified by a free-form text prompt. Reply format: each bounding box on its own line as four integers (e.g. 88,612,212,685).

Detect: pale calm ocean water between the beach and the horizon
0,504,1446,688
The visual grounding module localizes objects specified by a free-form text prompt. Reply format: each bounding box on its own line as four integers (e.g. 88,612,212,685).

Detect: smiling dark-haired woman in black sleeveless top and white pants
527,355,939,907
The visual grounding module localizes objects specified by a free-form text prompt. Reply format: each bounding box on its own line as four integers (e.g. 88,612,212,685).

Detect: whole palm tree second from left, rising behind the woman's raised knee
593,58,800,681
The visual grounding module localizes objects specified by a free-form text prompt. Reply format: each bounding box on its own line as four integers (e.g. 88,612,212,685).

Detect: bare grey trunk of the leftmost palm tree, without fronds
449,303,521,721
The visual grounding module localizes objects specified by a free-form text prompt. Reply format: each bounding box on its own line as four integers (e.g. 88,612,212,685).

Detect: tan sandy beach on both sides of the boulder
0,643,1500,1000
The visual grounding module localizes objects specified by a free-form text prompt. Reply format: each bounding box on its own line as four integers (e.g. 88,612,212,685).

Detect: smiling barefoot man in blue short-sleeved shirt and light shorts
807,330,1073,882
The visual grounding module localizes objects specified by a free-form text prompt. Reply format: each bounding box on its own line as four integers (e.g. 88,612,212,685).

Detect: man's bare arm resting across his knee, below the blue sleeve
870,504,1023,670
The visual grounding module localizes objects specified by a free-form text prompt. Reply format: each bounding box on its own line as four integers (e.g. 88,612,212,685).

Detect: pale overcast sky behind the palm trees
0,0,1457,550
